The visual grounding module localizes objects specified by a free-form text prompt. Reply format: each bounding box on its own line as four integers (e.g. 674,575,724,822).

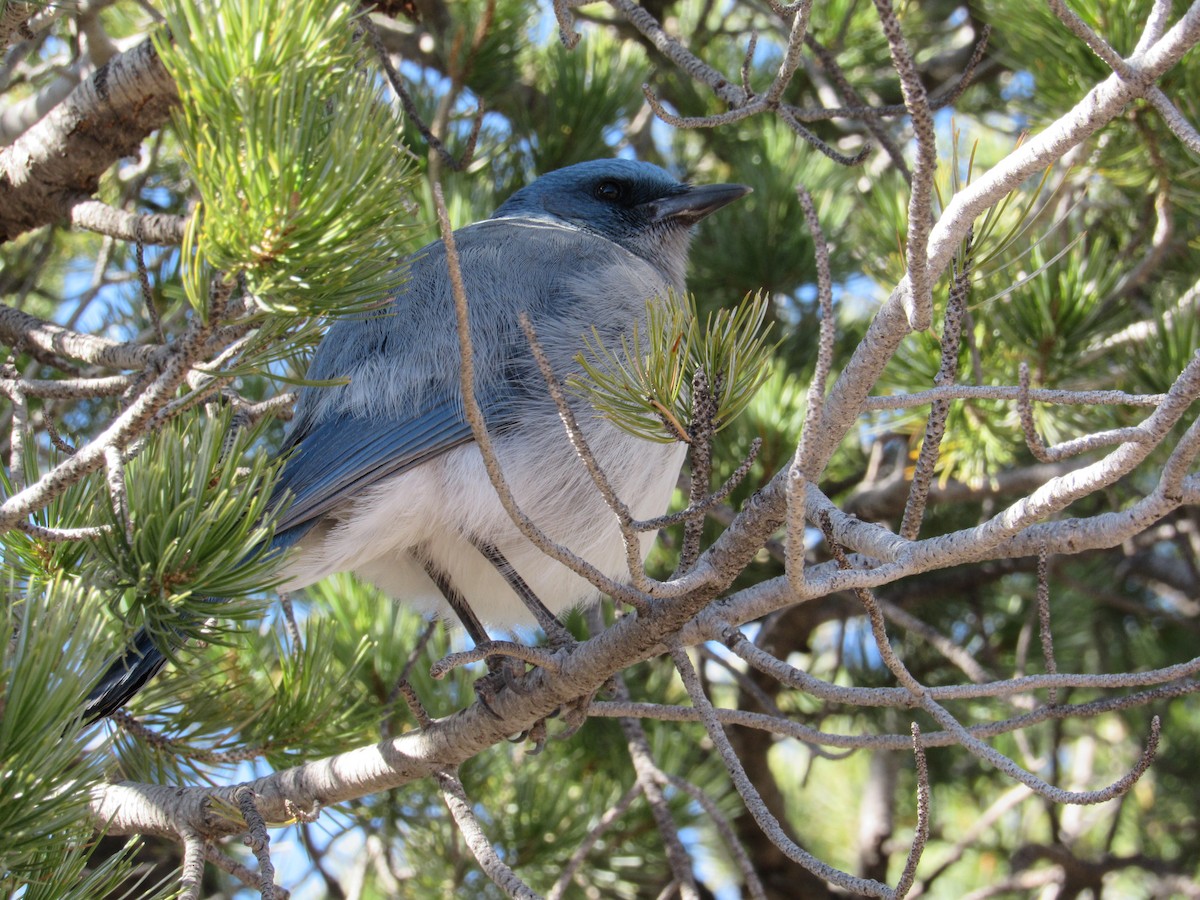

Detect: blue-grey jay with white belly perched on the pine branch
86,160,750,719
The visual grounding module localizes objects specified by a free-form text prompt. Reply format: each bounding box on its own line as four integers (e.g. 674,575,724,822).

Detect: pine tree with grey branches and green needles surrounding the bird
0,0,1200,899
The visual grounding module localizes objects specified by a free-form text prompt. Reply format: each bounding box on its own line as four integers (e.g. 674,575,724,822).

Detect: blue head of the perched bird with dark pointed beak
493,160,750,286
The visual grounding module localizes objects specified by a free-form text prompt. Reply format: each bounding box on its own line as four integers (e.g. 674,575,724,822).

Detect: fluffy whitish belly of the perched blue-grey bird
284,420,686,629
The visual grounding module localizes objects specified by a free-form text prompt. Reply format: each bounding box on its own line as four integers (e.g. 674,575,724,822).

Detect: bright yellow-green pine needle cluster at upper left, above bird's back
155,0,415,314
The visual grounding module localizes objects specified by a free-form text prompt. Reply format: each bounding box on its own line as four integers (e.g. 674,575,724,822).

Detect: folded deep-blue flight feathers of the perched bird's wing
267,403,482,548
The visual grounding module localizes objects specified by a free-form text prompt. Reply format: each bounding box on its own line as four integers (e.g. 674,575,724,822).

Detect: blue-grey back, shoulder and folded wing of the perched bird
274,218,664,547
